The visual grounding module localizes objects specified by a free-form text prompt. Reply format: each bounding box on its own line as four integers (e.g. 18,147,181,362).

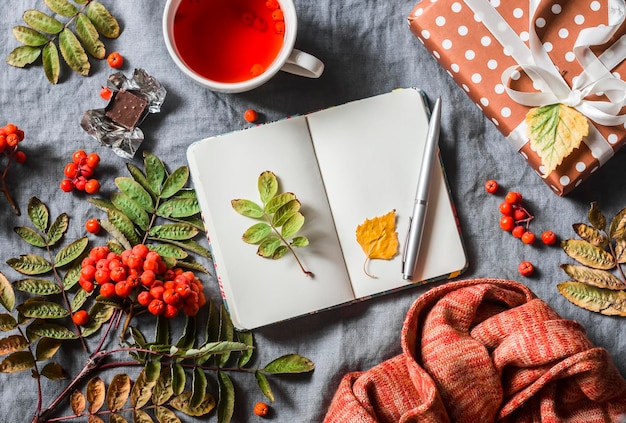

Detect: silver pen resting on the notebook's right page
402,98,441,280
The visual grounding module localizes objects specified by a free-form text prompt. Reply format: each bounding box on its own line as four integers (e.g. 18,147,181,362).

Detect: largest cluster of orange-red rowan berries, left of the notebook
79,244,206,318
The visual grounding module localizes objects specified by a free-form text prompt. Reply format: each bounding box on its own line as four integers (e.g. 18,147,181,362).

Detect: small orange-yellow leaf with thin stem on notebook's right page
356,210,398,277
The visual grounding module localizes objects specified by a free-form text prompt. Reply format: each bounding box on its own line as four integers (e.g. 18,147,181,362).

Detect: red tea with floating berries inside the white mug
173,0,285,83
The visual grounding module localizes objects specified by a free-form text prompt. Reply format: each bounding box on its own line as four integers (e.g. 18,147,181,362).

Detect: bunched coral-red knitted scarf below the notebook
325,279,626,423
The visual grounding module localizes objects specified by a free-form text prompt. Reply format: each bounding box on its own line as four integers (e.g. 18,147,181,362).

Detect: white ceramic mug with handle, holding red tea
163,0,324,93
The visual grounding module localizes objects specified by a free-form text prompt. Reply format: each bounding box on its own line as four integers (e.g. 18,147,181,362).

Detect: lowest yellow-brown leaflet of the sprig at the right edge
557,281,626,316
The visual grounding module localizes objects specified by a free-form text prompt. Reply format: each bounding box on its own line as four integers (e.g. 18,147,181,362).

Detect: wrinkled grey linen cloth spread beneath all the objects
0,0,626,423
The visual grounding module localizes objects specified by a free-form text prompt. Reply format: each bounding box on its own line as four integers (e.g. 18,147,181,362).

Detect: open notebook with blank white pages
187,89,467,329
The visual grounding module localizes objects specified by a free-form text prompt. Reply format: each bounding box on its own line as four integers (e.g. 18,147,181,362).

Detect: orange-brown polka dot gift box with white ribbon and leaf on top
409,0,626,195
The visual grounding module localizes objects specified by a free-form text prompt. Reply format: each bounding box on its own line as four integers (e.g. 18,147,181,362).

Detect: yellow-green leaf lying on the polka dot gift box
526,104,589,178
